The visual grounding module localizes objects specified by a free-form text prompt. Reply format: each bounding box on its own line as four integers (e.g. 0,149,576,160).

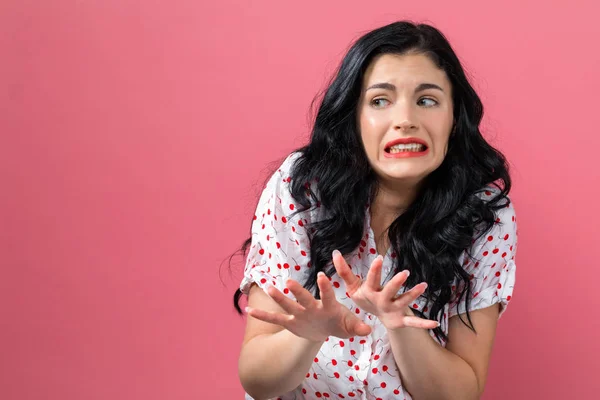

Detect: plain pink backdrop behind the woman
0,0,600,400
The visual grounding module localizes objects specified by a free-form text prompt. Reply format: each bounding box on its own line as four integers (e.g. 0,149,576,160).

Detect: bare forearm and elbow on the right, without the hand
388,305,498,400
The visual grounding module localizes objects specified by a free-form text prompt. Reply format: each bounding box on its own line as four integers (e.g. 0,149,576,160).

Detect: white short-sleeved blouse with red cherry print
240,155,517,400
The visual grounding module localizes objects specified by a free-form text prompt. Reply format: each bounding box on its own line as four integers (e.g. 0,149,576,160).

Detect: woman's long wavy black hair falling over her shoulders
234,21,511,340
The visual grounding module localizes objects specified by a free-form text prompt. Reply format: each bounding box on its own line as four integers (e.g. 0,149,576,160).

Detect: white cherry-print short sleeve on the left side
240,154,310,299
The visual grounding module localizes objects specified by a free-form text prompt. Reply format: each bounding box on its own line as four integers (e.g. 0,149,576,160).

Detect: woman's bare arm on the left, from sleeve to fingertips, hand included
239,272,371,398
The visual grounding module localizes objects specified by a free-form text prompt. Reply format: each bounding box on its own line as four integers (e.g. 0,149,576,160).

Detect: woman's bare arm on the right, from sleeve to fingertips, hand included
333,251,499,400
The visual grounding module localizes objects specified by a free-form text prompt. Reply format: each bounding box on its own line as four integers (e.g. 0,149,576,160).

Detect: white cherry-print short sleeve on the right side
448,192,517,318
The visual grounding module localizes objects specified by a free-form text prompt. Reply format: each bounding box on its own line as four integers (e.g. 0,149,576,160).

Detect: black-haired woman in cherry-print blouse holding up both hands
235,22,517,400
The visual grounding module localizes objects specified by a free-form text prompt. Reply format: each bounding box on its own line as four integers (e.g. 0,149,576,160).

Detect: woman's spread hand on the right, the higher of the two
333,250,439,330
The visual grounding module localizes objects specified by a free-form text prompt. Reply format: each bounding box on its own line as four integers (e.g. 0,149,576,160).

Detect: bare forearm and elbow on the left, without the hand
238,285,323,400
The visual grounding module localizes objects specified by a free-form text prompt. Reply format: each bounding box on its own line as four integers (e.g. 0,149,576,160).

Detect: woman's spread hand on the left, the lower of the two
246,272,371,342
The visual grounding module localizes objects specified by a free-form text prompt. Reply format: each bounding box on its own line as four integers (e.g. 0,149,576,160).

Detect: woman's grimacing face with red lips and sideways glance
358,54,454,186
